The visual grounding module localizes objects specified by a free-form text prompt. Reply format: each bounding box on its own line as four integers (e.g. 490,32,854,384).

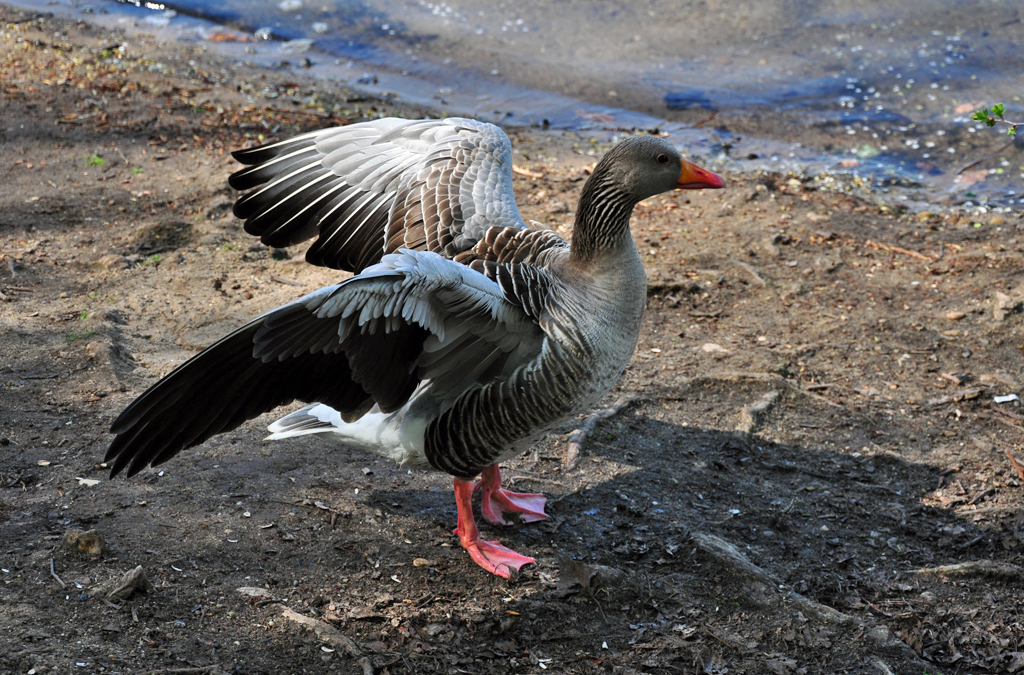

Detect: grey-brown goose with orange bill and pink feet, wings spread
105,118,723,578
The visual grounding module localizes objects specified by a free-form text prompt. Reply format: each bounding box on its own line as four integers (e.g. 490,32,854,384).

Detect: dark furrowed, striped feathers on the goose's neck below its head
570,162,640,264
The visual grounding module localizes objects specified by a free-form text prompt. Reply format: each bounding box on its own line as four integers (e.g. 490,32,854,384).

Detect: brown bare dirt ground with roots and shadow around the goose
0,5,1024,675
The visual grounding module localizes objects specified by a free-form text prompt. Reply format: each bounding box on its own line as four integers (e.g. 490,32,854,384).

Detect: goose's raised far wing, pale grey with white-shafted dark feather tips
230,118,526,272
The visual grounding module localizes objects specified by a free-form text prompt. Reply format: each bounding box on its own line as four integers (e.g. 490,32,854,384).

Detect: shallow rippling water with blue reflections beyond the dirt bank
9,0,1024,208
